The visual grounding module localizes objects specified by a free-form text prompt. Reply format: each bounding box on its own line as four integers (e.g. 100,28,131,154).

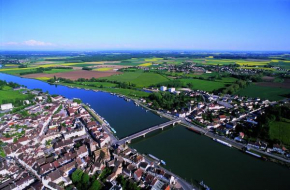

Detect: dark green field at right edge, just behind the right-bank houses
237,84,290,100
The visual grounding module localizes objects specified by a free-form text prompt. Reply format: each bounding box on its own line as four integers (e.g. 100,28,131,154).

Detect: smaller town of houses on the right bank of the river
139,86,290,163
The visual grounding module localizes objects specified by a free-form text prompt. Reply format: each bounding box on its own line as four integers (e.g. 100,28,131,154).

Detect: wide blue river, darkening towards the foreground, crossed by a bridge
0,73,290,190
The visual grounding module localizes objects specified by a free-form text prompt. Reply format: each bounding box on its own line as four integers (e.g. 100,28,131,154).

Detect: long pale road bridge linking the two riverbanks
117,118,181,145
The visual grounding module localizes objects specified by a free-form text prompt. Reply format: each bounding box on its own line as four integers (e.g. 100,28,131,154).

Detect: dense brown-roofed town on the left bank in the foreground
0,85,186,190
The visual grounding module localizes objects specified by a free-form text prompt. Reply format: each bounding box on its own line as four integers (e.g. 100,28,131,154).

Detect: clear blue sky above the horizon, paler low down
0,0,290,51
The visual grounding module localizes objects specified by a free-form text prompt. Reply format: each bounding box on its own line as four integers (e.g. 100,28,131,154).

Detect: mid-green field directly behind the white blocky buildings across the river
180,79,225,92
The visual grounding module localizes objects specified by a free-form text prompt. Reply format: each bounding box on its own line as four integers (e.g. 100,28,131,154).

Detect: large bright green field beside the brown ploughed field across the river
105,72,169,87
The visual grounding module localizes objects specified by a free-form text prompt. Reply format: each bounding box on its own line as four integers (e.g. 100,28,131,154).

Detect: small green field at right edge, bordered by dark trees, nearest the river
269,119,290,146
